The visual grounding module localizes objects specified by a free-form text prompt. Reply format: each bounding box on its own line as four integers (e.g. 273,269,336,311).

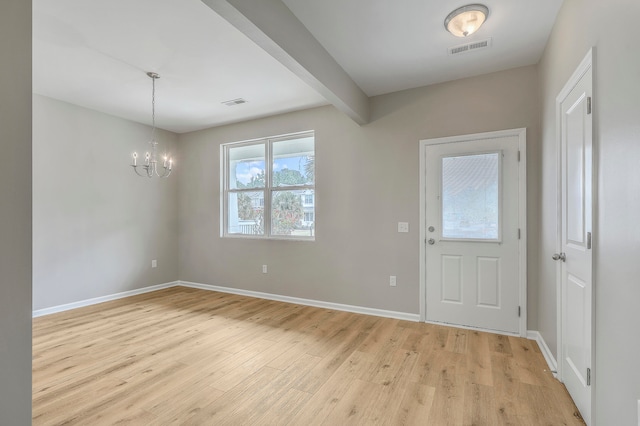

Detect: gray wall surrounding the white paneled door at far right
538,0,640,425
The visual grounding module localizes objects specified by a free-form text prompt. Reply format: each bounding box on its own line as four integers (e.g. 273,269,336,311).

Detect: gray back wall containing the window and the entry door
179,67,539,320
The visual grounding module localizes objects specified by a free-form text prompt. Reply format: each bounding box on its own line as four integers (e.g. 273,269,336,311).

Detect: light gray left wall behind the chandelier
33,95,180,310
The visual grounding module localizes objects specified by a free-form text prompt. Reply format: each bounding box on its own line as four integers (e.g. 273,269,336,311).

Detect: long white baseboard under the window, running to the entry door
179,281,420,322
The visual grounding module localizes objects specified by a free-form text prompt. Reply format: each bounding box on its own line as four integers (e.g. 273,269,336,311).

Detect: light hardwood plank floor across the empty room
33,287,583,426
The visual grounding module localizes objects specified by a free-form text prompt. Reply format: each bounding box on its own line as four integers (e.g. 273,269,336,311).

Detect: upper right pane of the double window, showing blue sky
271,136,315,186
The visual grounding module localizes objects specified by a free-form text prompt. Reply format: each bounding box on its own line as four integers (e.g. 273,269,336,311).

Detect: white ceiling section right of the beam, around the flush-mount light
283,0,562,96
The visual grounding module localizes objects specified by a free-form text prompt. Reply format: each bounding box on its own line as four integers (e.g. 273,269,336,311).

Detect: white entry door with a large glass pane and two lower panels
424,129,525,333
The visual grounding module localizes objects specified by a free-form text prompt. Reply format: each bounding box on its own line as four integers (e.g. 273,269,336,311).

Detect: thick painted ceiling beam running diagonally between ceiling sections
202,0,369,125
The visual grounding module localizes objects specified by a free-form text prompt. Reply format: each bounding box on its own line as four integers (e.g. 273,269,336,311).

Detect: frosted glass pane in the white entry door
442,153,500,240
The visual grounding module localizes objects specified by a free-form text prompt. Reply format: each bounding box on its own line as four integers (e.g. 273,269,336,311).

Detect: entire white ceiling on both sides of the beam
33,0,562,133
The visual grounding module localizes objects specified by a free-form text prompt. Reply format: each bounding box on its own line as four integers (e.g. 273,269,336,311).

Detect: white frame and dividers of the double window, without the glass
220,131,317,241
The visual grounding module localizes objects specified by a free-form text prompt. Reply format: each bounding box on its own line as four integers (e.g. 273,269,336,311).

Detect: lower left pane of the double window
227,191,264,235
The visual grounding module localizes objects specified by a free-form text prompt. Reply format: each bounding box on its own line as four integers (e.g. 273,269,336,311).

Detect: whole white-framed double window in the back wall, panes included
221,132,315,240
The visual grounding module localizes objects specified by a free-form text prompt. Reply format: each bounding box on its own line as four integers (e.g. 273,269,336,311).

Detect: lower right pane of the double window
271,190,315,237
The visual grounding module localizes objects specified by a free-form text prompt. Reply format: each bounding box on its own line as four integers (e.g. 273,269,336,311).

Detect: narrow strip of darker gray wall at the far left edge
0,0,31,426
